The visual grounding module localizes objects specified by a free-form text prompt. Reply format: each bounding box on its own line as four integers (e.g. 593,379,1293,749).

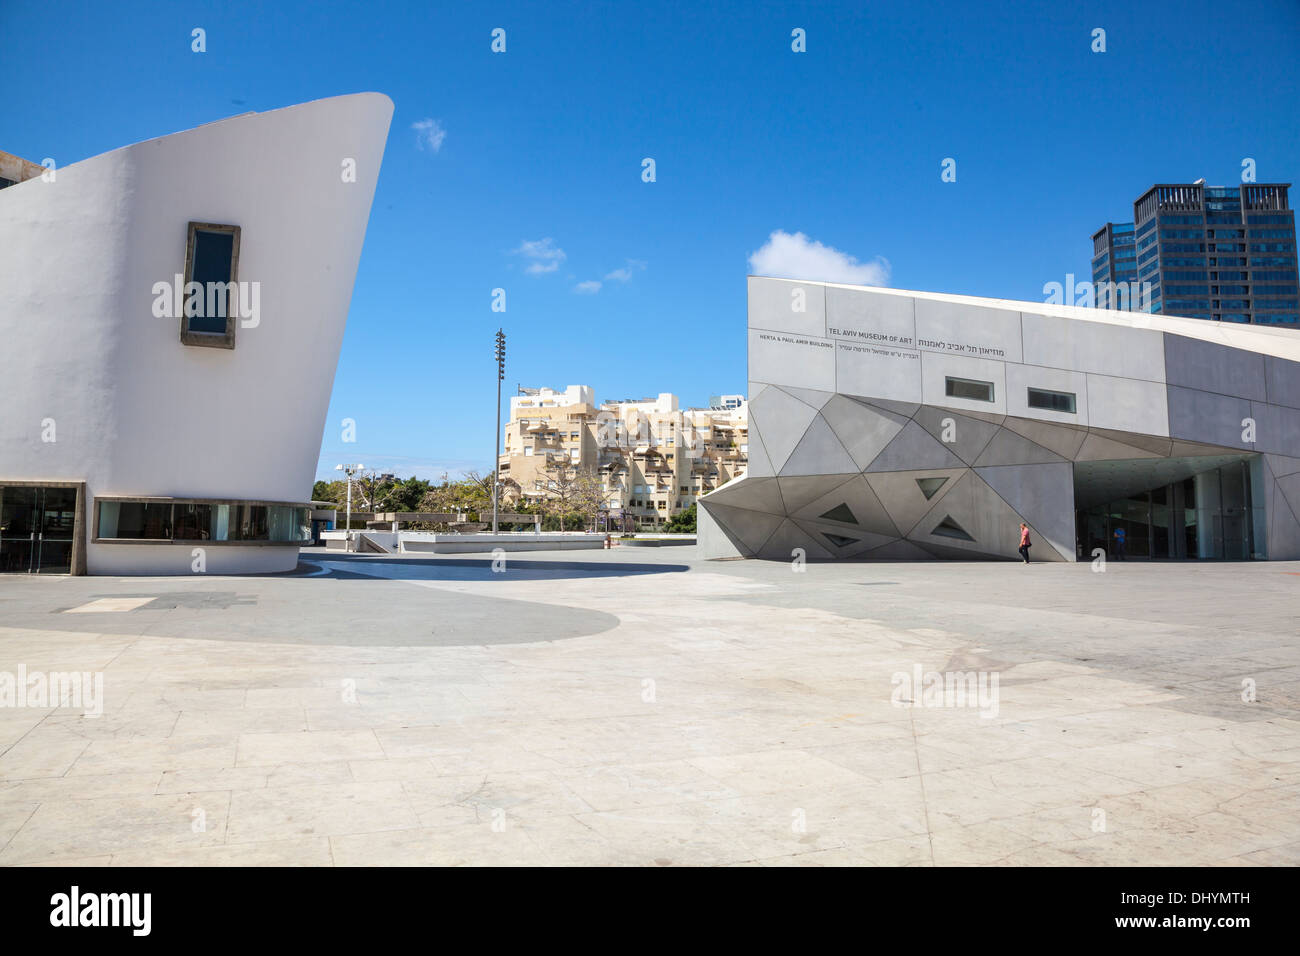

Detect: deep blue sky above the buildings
0,0,1300,477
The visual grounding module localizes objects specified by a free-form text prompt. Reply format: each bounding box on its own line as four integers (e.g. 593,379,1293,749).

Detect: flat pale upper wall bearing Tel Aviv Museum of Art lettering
749,277,1185,436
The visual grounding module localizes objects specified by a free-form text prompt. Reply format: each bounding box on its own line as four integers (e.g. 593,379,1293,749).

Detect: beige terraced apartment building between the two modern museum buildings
498,385,749,528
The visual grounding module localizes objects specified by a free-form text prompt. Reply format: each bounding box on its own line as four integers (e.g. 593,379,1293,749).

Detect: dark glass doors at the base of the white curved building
0,484,78,575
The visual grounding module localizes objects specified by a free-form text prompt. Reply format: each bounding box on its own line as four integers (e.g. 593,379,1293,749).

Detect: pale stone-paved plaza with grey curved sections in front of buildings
0,548,1300,865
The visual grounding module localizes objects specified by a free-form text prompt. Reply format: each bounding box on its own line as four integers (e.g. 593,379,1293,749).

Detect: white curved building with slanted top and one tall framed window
0,92,393,574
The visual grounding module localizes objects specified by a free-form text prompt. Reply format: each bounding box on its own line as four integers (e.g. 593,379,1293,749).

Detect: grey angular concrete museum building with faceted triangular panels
699,277,1300,561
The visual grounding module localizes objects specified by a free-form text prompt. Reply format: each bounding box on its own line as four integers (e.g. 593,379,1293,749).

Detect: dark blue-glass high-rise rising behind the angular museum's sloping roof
1092,182,1300,328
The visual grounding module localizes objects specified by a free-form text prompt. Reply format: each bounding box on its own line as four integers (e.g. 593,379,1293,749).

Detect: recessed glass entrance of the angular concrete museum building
1075,455,1264,561
